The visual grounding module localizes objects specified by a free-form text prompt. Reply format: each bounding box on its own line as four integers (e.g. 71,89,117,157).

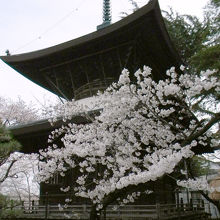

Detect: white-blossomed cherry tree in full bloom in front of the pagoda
40,66,220,219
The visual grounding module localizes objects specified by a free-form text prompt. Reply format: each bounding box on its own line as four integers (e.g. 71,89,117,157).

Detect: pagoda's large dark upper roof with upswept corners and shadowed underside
0,0,180,100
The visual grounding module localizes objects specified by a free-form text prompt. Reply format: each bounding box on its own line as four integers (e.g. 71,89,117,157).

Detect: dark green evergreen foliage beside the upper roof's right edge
164,0,220,73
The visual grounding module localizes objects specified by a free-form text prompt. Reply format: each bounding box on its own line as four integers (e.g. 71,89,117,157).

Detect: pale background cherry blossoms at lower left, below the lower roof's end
0,153,39,207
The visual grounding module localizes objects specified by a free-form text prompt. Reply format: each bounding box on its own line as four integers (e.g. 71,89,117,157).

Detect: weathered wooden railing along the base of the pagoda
10,204,209,220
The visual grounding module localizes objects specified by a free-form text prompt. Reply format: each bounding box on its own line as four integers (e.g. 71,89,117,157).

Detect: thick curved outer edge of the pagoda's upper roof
0,0,162,62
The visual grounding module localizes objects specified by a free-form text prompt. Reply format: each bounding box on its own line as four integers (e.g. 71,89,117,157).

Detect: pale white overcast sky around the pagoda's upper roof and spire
0,0,208,106
